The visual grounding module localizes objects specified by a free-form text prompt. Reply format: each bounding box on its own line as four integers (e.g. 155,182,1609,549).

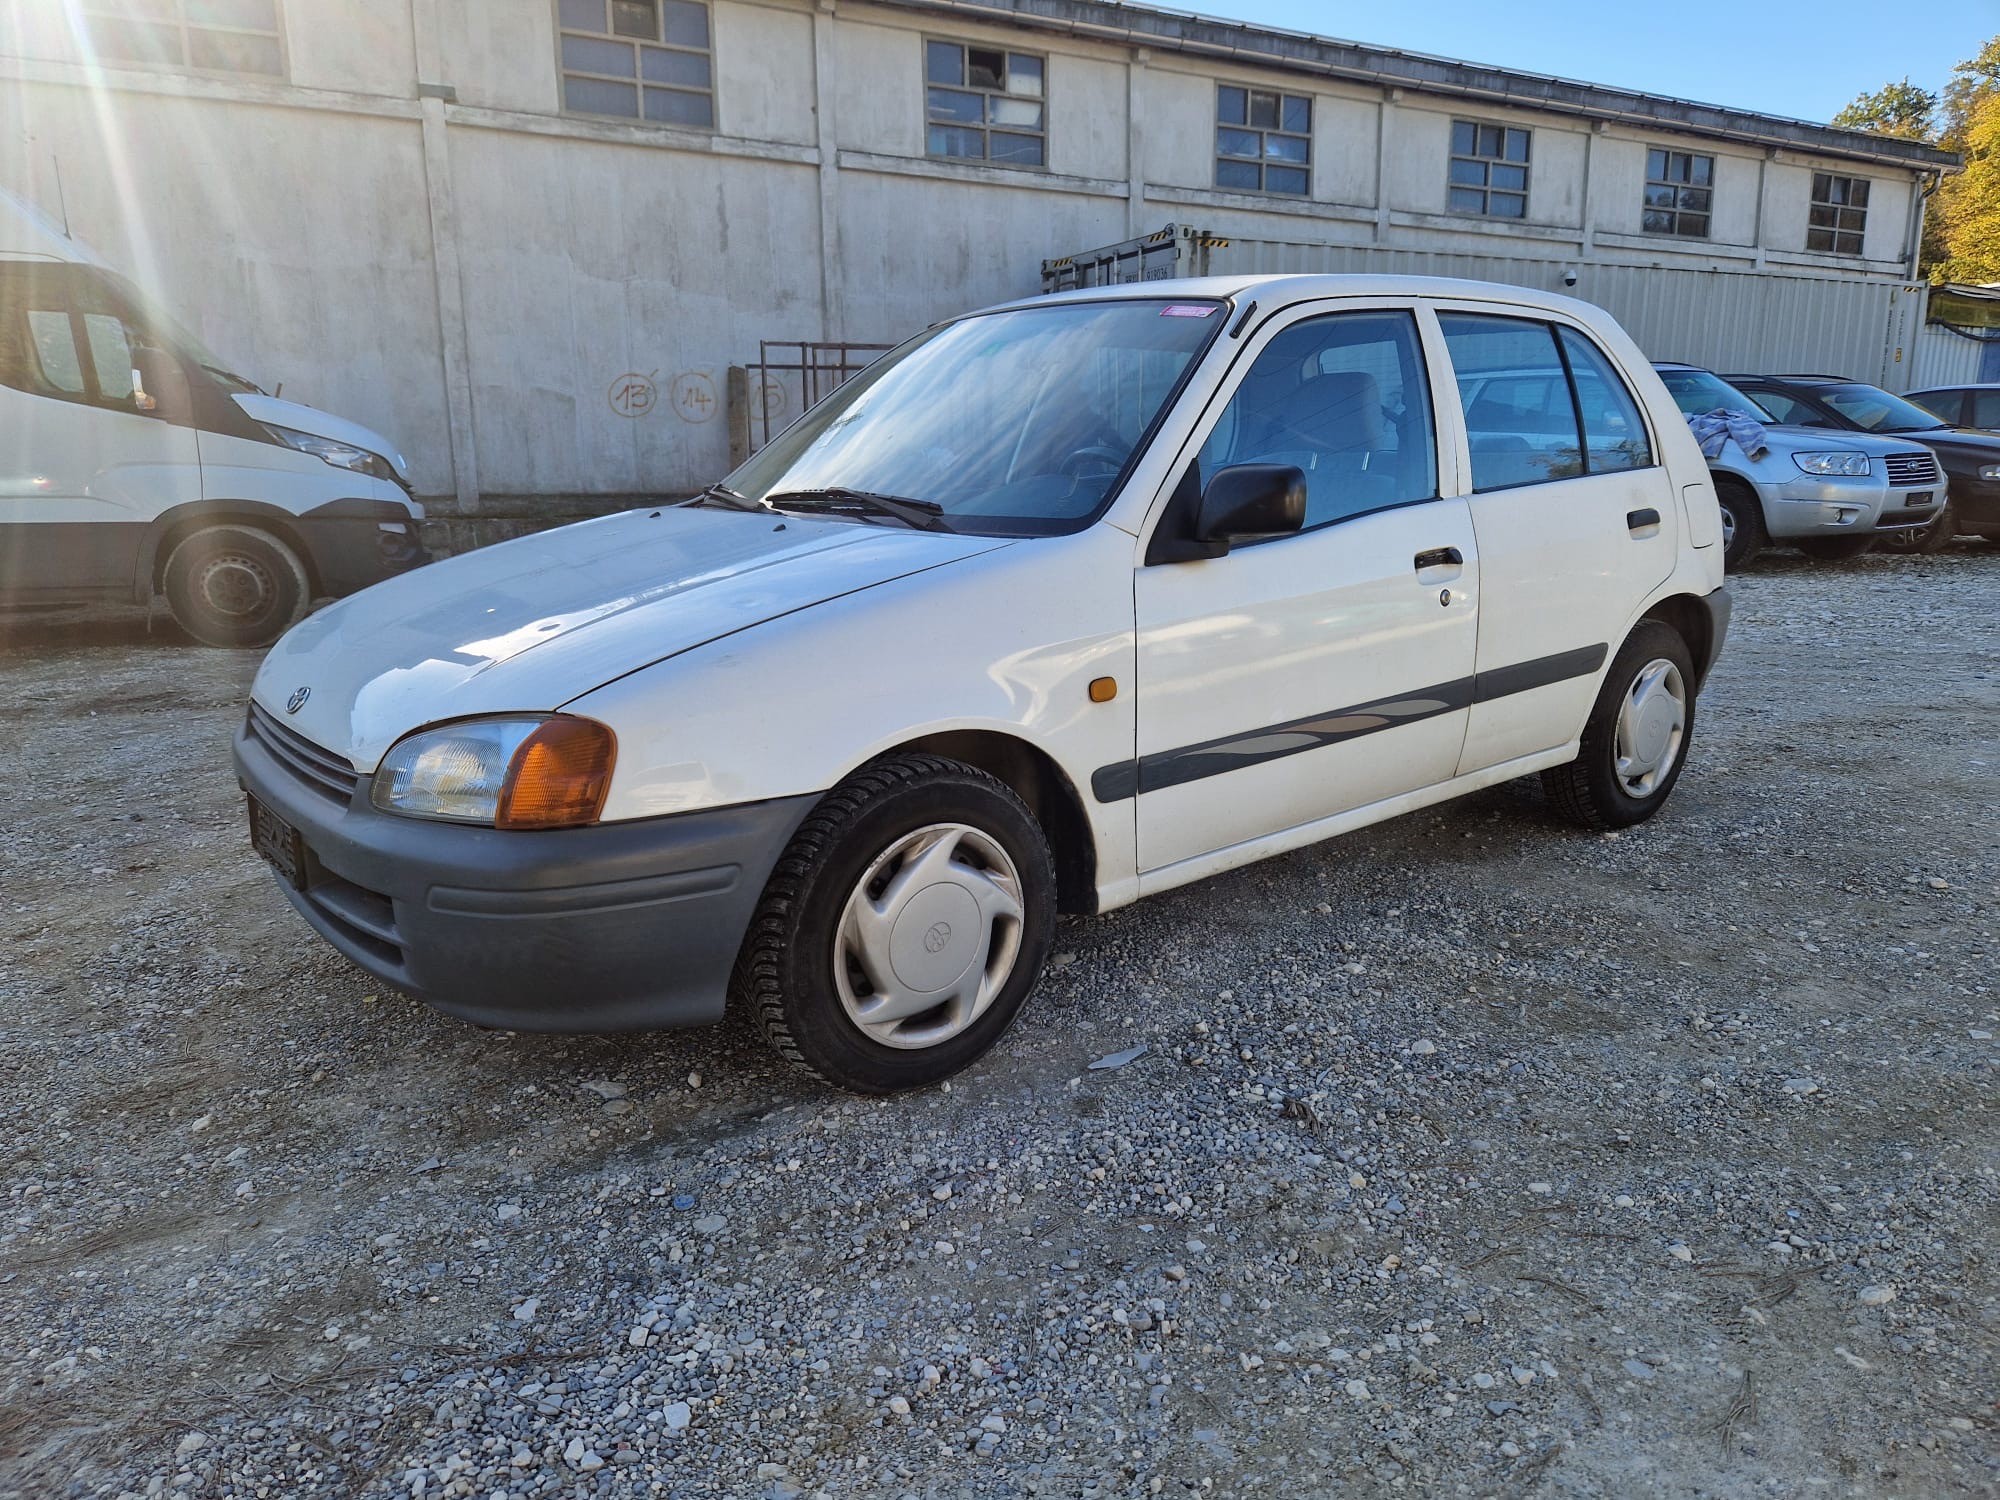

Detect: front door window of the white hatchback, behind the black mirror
1200,312,1438,528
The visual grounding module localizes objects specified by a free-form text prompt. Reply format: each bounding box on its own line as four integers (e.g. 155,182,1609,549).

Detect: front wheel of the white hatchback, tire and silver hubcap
730,754,1056,1094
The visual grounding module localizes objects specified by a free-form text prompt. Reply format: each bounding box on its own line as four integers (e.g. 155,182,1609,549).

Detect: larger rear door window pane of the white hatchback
1438,312,1584,490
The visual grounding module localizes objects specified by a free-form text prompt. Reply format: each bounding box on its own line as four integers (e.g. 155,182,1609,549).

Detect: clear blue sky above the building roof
1192,0,2000,120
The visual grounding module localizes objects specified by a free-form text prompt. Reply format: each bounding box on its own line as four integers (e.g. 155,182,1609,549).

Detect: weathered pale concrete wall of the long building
0,0,1936,504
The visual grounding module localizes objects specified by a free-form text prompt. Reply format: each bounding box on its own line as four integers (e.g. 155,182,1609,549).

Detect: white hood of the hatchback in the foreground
252,506,1010,772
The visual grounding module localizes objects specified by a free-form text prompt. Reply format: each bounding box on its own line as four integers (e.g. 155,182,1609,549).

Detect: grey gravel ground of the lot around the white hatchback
0,546,2000,1500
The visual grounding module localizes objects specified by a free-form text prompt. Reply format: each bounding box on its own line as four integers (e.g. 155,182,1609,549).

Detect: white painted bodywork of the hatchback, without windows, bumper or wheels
254,276,1722,924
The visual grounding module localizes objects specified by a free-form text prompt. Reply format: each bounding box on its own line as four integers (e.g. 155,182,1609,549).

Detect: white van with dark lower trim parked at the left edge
0,192,428,646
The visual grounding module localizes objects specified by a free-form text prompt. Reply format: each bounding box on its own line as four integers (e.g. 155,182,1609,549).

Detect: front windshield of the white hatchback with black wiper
728,298,1228,536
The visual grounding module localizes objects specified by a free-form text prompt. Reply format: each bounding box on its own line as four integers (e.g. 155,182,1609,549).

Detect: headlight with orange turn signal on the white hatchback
370,714,618,828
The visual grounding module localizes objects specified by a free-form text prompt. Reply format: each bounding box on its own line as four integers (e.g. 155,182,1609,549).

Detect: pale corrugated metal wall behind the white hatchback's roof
1208,240,1930,390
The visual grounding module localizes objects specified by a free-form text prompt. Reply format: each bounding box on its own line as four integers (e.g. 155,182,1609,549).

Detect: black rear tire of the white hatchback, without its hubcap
1542,620,1694,830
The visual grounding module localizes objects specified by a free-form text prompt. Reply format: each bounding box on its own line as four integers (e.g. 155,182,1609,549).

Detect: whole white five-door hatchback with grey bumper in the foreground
236,276,1728,1092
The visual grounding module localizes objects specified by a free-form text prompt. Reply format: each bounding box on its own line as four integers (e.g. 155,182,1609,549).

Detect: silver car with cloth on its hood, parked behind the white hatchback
1654,362,1944,568
